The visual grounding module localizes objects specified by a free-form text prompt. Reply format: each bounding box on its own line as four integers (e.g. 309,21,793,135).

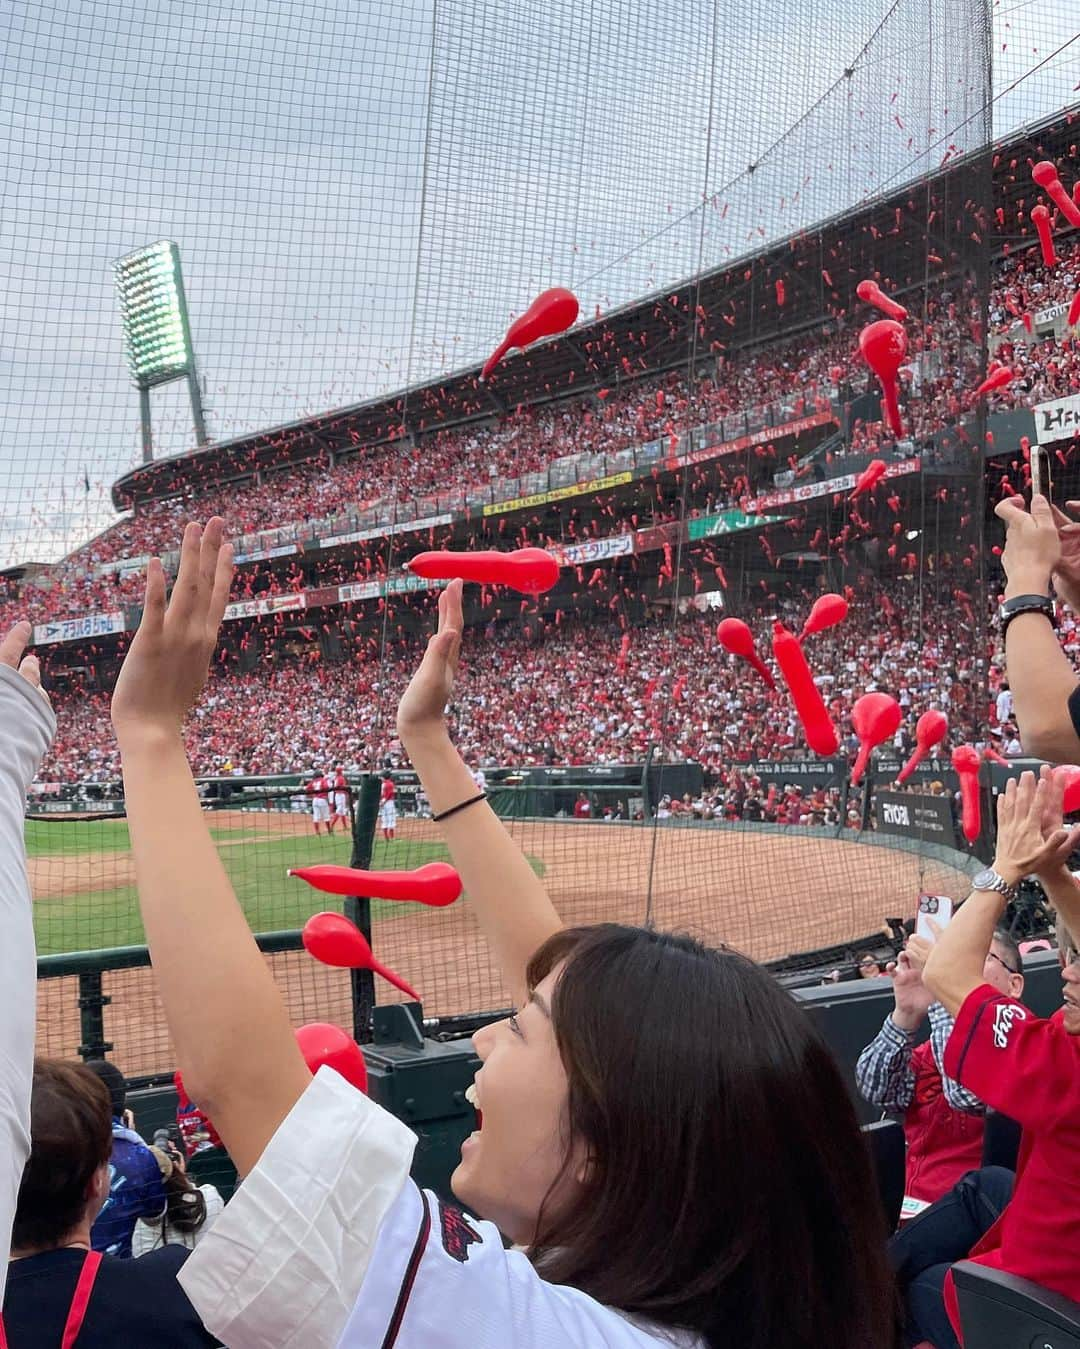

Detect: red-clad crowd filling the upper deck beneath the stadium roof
0,244,1080,652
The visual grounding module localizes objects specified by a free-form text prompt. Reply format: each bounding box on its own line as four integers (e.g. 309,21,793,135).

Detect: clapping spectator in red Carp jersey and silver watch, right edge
894,777,1080,1349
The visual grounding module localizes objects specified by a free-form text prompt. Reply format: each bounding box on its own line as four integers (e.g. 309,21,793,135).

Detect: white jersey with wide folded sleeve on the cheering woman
178,1067,704,1349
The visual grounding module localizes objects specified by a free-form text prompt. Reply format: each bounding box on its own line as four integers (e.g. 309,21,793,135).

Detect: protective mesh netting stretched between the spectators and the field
0,0,1080,1074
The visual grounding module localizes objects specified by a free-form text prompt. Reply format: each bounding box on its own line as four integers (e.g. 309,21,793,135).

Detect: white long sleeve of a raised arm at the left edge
0,665,57,1303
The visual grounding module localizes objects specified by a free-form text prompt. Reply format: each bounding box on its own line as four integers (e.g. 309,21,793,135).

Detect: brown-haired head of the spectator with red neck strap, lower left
11,1059,112,1255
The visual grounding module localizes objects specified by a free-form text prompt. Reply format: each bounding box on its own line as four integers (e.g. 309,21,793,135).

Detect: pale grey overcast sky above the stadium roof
0,0,1080,564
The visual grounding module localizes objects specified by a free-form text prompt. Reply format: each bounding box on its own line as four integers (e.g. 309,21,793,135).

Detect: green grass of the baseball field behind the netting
26,816,458,955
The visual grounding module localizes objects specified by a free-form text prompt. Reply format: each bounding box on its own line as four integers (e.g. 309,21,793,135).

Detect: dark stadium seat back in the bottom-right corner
952,1260,1080,1349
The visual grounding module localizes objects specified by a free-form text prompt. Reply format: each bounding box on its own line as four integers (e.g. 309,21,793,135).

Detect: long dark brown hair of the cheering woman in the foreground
529,924,898,1349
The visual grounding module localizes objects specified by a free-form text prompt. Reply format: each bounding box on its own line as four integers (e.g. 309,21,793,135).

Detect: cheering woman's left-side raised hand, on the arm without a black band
112,517,233,741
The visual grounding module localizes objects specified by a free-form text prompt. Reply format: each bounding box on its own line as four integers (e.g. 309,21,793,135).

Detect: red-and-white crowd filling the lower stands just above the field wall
42,577,1003,787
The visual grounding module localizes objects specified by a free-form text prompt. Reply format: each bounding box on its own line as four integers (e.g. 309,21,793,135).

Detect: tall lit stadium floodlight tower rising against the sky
113,239,206,463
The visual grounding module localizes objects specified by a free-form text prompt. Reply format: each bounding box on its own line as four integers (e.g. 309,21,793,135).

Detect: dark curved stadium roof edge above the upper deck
112,104,1080,510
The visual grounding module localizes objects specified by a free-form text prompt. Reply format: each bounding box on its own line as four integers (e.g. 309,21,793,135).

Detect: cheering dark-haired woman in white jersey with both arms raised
113,519,897,1349
